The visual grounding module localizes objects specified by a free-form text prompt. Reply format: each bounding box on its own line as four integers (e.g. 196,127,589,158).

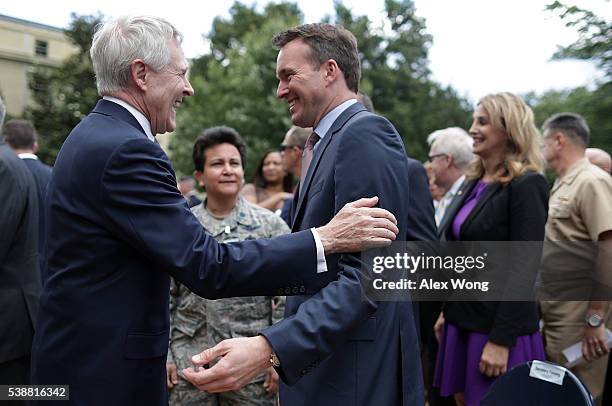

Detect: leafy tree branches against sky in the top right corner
546,1,612,80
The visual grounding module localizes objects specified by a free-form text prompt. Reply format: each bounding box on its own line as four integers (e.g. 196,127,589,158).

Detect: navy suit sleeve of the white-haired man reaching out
99,138,321,299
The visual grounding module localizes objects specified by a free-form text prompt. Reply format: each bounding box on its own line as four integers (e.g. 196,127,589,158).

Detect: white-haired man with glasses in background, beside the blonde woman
427,127,474,229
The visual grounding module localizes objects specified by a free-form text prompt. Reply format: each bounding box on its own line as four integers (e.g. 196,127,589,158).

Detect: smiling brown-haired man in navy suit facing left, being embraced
188,24,435,406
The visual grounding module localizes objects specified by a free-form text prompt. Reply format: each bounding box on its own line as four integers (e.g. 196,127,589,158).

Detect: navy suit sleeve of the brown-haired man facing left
262,115,407,385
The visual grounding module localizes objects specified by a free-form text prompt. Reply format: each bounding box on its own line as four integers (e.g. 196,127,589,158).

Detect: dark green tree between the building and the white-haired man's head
26,13,103,164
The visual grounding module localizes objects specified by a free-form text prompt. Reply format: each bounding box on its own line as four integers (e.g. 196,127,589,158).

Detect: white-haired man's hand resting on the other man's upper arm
317,196,399,255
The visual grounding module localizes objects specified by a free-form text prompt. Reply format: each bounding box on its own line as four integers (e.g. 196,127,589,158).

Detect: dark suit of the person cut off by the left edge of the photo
0,142,40,384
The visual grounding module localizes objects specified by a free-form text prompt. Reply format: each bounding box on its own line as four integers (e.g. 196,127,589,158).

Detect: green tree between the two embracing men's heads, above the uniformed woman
170,2,302,178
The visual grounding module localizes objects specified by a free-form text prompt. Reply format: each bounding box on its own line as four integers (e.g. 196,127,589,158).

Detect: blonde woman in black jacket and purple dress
434,93,548,406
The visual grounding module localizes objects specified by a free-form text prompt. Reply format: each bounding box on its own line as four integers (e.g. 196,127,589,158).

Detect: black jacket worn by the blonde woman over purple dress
440,172,548,347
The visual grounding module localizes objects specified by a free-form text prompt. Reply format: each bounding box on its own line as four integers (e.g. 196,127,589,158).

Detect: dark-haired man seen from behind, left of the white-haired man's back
2,119,51,283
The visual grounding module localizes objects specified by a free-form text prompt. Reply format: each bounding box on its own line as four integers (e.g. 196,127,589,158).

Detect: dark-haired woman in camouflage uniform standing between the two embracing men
167,127,289,406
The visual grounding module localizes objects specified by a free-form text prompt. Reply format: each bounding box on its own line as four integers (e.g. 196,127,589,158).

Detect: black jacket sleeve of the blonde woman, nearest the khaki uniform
488,173,548,347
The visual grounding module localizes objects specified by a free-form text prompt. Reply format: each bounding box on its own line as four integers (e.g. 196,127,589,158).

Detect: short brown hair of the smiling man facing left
272,23,361,93
